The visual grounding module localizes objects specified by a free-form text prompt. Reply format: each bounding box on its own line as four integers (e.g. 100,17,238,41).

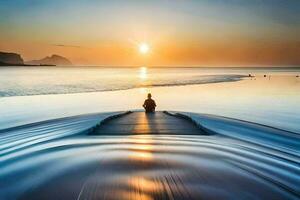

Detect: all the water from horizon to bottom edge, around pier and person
0,67,300,199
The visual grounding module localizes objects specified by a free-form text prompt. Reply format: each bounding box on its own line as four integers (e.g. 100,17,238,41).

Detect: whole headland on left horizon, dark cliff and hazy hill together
0,52,72,66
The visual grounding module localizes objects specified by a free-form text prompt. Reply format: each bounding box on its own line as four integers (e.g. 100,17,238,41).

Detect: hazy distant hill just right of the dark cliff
26,55,72,65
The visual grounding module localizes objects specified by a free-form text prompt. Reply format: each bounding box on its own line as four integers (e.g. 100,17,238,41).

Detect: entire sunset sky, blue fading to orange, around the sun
0,0,300,66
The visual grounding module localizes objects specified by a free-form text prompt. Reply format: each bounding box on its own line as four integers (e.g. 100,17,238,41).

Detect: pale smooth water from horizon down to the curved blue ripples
0,67,300,132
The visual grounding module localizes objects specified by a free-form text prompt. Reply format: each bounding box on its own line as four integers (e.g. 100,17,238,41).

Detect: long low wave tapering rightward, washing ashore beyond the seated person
0,74,246,97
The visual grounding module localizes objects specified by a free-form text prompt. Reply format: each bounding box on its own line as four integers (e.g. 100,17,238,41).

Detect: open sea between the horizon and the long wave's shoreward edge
0,67,300,97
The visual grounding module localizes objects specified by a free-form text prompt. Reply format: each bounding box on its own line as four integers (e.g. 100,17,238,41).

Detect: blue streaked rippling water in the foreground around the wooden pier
0,113,300,199
